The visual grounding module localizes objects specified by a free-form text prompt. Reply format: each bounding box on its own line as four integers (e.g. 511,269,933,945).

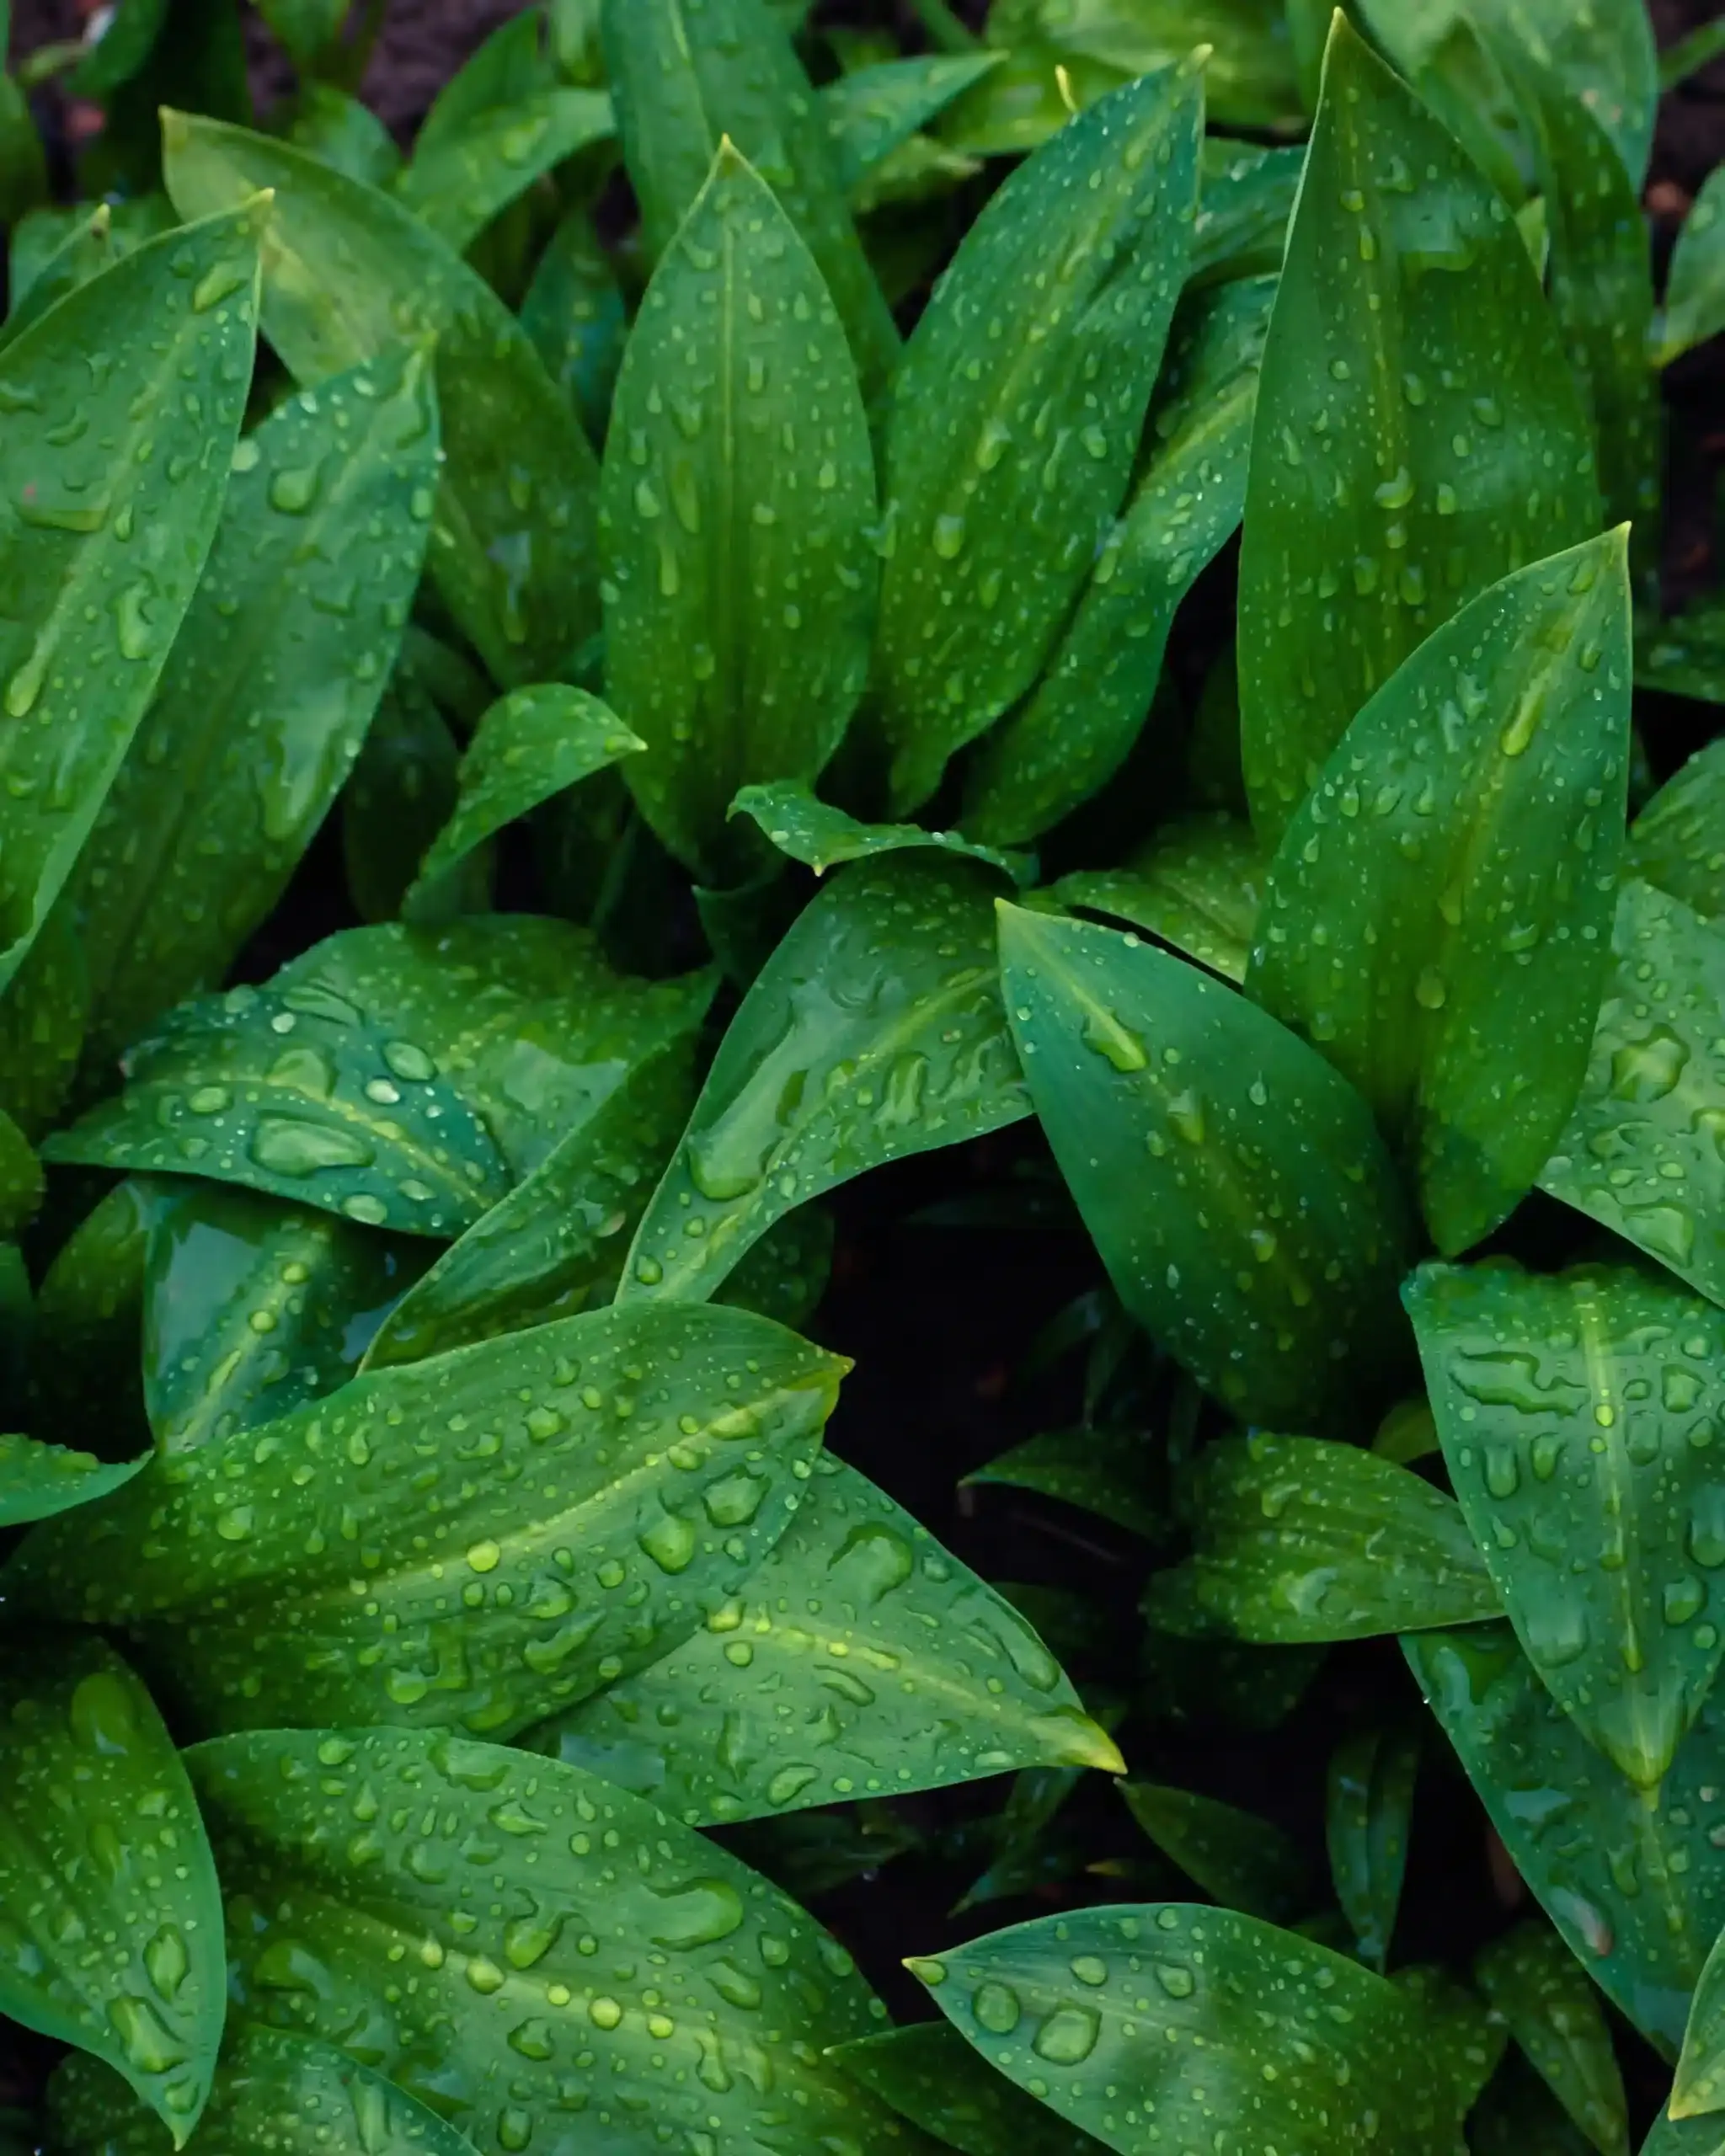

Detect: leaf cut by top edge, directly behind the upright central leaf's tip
600,0,900,405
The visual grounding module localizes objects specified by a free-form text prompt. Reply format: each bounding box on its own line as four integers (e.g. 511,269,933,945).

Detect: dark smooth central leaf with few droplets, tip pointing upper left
1001,904,1408,1428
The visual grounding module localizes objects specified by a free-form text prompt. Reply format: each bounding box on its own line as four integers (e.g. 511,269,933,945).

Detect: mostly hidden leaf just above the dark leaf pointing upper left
1055,813,1266,981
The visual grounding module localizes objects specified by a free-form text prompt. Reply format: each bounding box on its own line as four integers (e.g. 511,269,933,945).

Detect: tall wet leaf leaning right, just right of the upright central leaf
873,65,1203,813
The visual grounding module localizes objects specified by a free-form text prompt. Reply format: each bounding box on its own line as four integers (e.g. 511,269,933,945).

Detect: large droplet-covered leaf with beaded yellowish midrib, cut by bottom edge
188,1729,933,2156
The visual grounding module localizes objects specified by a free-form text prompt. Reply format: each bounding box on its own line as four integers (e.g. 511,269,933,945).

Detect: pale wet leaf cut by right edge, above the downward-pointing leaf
1540,882,1725,1302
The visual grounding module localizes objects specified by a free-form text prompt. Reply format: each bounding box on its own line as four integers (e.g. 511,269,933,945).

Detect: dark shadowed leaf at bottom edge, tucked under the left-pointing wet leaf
828,2022,1102,2156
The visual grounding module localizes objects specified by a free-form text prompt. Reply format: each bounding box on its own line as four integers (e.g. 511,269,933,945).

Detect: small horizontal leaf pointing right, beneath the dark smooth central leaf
1145,1436,1501,1647
